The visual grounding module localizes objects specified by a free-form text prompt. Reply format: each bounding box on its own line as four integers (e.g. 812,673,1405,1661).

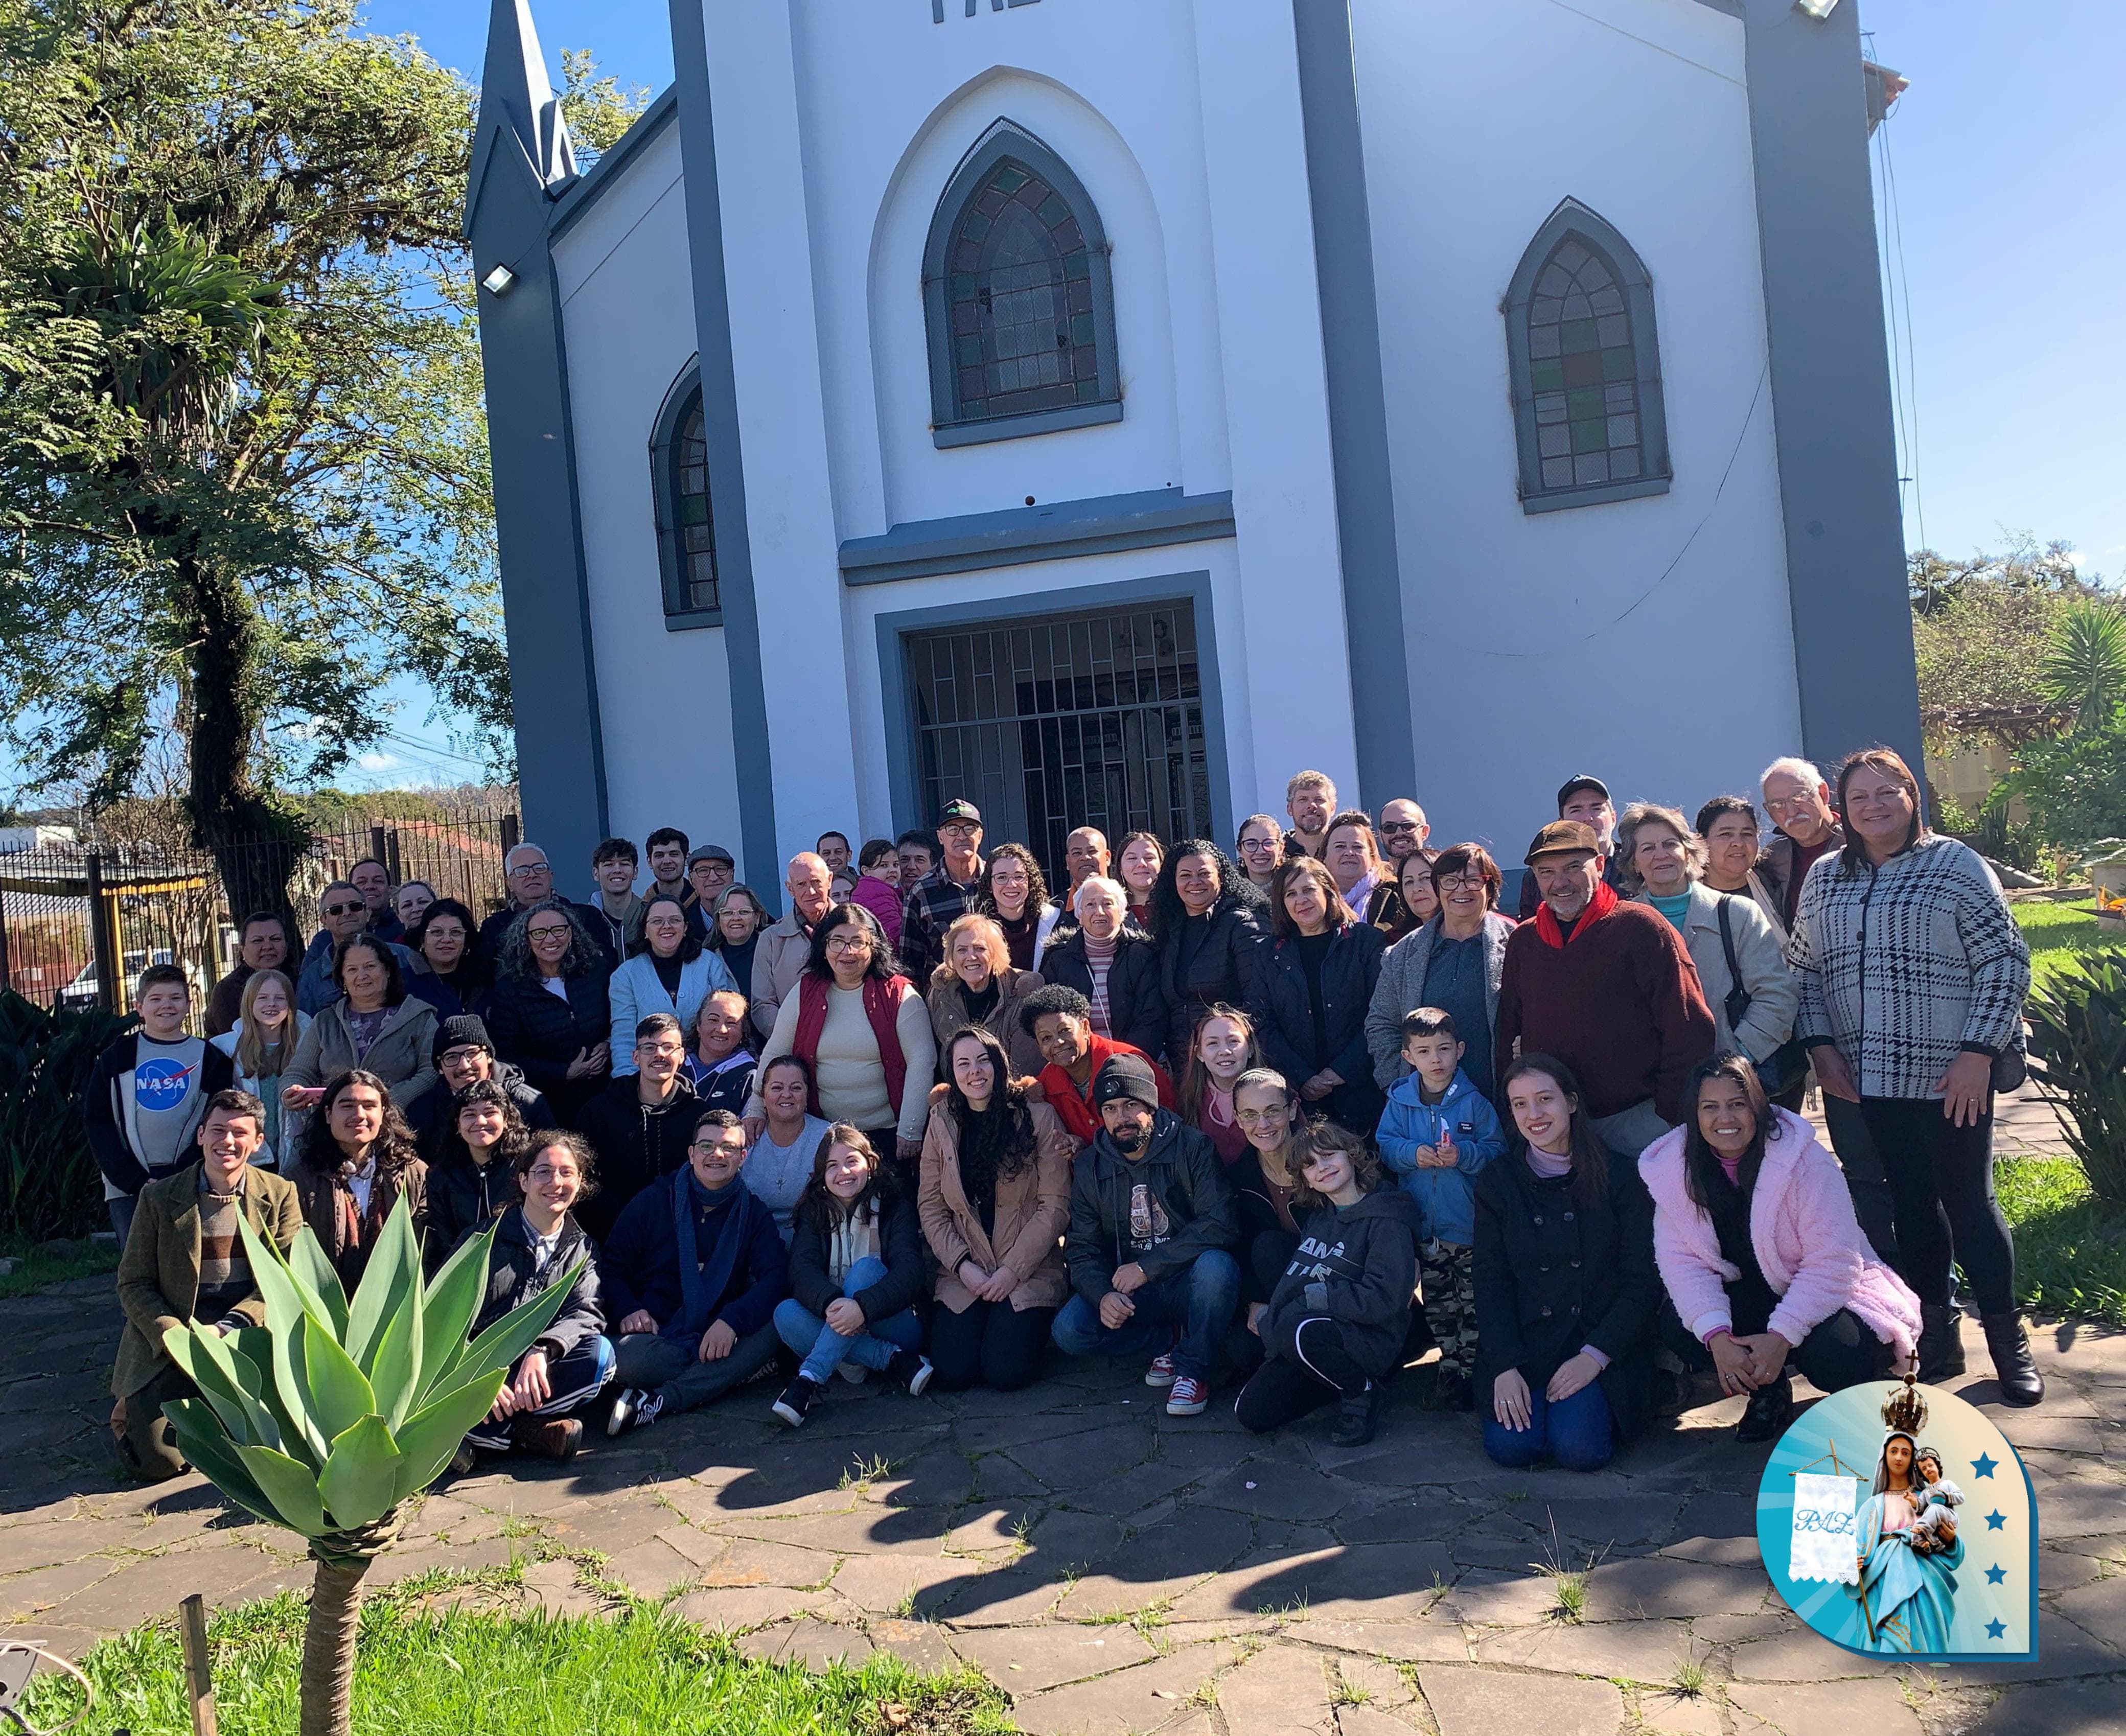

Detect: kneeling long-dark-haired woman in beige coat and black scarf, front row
916,1026,1076,1392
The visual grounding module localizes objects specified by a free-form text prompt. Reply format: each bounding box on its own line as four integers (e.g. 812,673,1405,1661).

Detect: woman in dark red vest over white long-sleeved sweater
746,903,938,1175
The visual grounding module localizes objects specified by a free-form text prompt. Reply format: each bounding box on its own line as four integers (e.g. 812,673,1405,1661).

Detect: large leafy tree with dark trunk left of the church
0,0,634,910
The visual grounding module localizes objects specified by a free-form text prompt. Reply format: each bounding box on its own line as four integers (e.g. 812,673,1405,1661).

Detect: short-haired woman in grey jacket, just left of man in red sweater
1365,844,1518,1107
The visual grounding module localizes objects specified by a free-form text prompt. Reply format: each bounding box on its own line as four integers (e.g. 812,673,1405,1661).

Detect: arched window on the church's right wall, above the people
1505,200,1671,512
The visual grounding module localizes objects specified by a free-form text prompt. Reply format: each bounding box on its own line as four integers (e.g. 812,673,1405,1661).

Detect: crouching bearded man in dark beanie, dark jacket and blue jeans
1050,1054,1239,1417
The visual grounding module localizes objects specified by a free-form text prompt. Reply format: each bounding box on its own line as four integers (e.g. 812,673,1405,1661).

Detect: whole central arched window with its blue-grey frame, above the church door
922,121,1122,446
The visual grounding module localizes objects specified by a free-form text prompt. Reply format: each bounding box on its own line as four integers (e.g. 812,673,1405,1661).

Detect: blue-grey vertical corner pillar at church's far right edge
1745,0,1920,765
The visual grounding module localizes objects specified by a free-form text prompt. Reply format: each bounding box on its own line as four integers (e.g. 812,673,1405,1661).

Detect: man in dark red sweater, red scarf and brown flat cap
1492,820,1714,1158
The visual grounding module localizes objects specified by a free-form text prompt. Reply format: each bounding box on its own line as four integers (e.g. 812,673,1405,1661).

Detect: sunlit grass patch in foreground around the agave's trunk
28,1591,1012,1736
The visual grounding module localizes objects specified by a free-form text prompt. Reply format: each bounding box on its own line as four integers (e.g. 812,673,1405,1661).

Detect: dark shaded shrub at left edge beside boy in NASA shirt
0,990,134,1241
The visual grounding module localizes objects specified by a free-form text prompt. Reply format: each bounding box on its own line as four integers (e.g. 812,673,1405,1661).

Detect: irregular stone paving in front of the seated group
0,1279,2126,1736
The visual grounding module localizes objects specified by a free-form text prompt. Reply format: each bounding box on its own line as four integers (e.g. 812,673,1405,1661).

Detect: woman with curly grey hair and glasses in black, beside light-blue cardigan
487,899,612,1126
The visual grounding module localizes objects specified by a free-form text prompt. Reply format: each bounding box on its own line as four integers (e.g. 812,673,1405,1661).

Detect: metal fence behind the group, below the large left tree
0,807,519,1018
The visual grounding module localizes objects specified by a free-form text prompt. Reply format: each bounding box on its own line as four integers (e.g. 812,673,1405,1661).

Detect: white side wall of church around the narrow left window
548,127,738,867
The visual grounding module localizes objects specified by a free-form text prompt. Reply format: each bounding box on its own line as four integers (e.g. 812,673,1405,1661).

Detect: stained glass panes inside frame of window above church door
946,159,1101,421
